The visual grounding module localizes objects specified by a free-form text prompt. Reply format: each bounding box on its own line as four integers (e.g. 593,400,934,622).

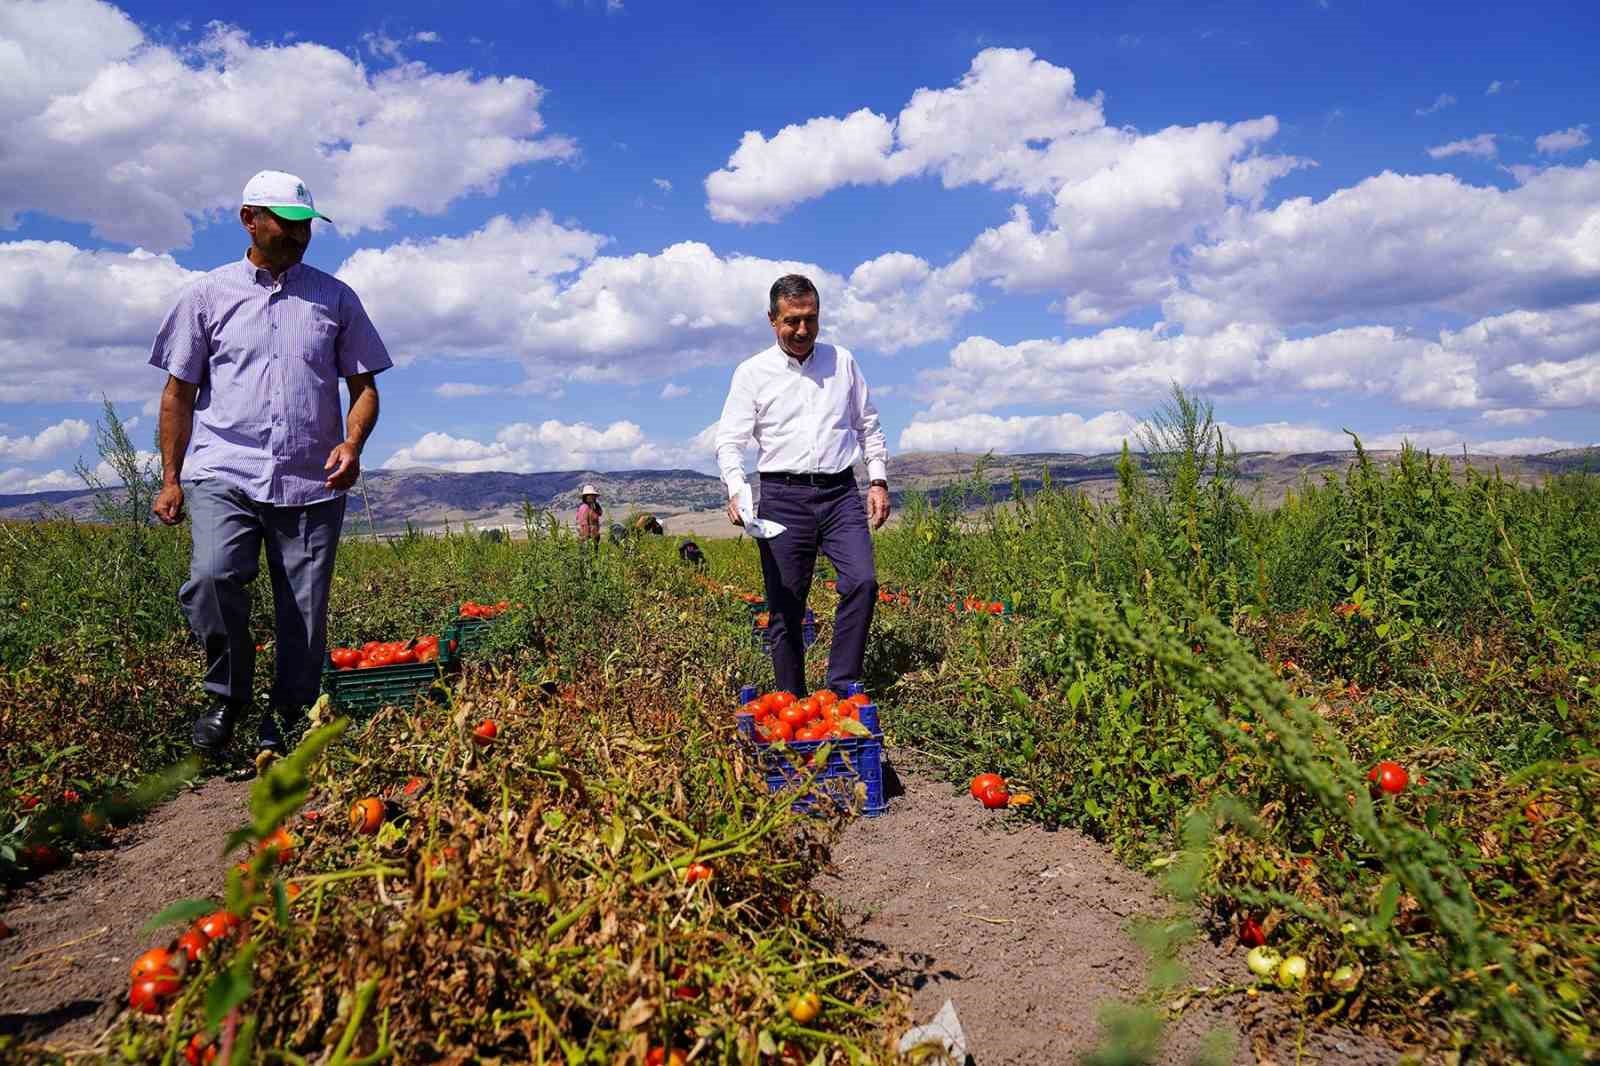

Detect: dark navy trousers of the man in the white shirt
755,477,878,696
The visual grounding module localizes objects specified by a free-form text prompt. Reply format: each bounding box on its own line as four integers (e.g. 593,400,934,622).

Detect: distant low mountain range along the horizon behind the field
0,447,1600,536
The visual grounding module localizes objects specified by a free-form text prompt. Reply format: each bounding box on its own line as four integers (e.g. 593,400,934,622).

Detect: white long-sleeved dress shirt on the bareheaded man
717,344,890,496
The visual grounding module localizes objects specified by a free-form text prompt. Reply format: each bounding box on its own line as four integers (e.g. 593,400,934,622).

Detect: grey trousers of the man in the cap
178,477,344,707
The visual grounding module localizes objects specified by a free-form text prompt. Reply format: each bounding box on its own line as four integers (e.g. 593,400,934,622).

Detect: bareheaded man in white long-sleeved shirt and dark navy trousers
717,274,890,695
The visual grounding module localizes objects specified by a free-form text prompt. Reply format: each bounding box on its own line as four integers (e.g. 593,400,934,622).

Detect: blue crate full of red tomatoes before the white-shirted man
738,683,888,816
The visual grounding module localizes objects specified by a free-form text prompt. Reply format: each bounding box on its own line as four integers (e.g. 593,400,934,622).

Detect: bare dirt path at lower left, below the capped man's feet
0,778,250,1052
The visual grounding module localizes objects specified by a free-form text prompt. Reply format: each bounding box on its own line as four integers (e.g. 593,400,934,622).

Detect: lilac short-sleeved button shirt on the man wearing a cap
150,258,394,507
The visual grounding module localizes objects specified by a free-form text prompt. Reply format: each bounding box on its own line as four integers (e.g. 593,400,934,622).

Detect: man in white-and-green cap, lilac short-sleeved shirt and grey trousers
150,170,394,754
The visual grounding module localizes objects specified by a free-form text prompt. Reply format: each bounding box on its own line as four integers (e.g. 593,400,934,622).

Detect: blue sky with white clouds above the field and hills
0,0,1600,491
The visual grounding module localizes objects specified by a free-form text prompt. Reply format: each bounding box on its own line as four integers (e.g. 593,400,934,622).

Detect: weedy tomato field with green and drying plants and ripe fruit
0,419,1600,1063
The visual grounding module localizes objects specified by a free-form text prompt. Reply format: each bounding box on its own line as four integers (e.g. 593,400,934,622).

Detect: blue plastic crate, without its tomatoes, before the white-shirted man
738,685,888,818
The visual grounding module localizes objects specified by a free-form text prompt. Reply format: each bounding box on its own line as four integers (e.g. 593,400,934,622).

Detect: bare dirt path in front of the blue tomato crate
816,755,1398,1066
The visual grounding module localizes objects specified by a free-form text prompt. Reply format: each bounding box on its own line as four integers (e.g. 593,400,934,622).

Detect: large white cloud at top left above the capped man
0,0,576,250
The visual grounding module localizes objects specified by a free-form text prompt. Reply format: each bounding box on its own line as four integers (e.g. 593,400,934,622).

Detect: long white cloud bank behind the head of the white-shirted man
338,214,976,384
